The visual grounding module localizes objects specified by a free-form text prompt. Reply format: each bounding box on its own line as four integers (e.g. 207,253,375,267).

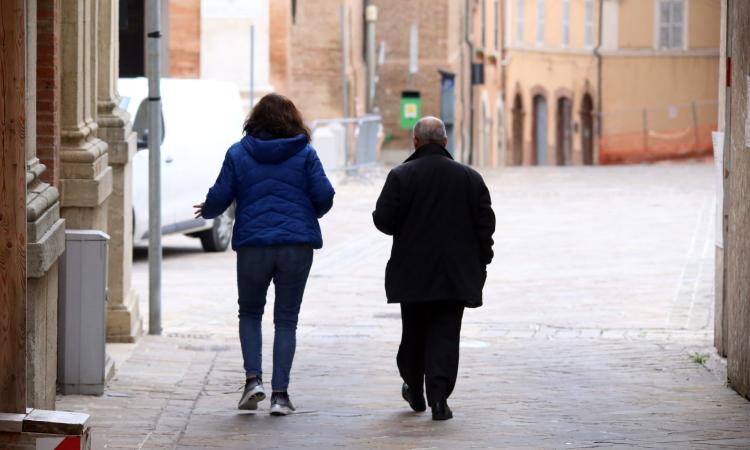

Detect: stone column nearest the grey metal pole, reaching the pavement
97,0,142,342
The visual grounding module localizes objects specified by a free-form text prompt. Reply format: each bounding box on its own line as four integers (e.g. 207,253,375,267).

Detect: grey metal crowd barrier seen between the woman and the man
310,115,383,173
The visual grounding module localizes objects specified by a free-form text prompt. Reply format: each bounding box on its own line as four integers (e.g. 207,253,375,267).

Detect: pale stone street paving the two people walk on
58,164,750,449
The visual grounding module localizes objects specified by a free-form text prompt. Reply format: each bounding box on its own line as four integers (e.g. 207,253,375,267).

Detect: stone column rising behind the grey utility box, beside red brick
60,0,112,231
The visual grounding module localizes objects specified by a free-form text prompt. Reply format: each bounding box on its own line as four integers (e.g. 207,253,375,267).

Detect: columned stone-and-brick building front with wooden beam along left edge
0,0,140,449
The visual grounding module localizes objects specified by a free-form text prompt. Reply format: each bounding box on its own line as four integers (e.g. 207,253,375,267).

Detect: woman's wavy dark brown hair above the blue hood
243,93,310,141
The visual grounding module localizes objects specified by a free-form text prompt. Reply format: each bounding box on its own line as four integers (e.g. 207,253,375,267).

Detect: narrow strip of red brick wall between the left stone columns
36,0,61,186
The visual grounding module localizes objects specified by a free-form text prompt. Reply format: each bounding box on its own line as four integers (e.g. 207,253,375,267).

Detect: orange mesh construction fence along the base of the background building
599,101,718,164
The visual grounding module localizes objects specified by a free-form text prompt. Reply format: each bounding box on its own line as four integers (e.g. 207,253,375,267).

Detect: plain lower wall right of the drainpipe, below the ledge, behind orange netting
600,56,719,163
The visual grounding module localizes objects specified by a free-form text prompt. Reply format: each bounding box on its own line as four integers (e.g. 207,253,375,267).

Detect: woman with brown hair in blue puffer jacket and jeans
196,94,334,415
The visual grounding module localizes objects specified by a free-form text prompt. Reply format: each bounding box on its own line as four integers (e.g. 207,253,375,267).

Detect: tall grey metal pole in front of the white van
146,0,162,334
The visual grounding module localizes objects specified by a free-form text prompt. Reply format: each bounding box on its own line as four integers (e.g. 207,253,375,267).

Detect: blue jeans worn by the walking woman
237,245,313,391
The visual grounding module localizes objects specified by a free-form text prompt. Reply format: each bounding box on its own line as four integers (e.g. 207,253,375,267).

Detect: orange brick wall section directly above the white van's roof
169,0,201,78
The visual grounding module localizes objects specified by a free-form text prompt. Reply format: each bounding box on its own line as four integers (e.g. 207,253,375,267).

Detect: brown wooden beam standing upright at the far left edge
0,0,26,414
